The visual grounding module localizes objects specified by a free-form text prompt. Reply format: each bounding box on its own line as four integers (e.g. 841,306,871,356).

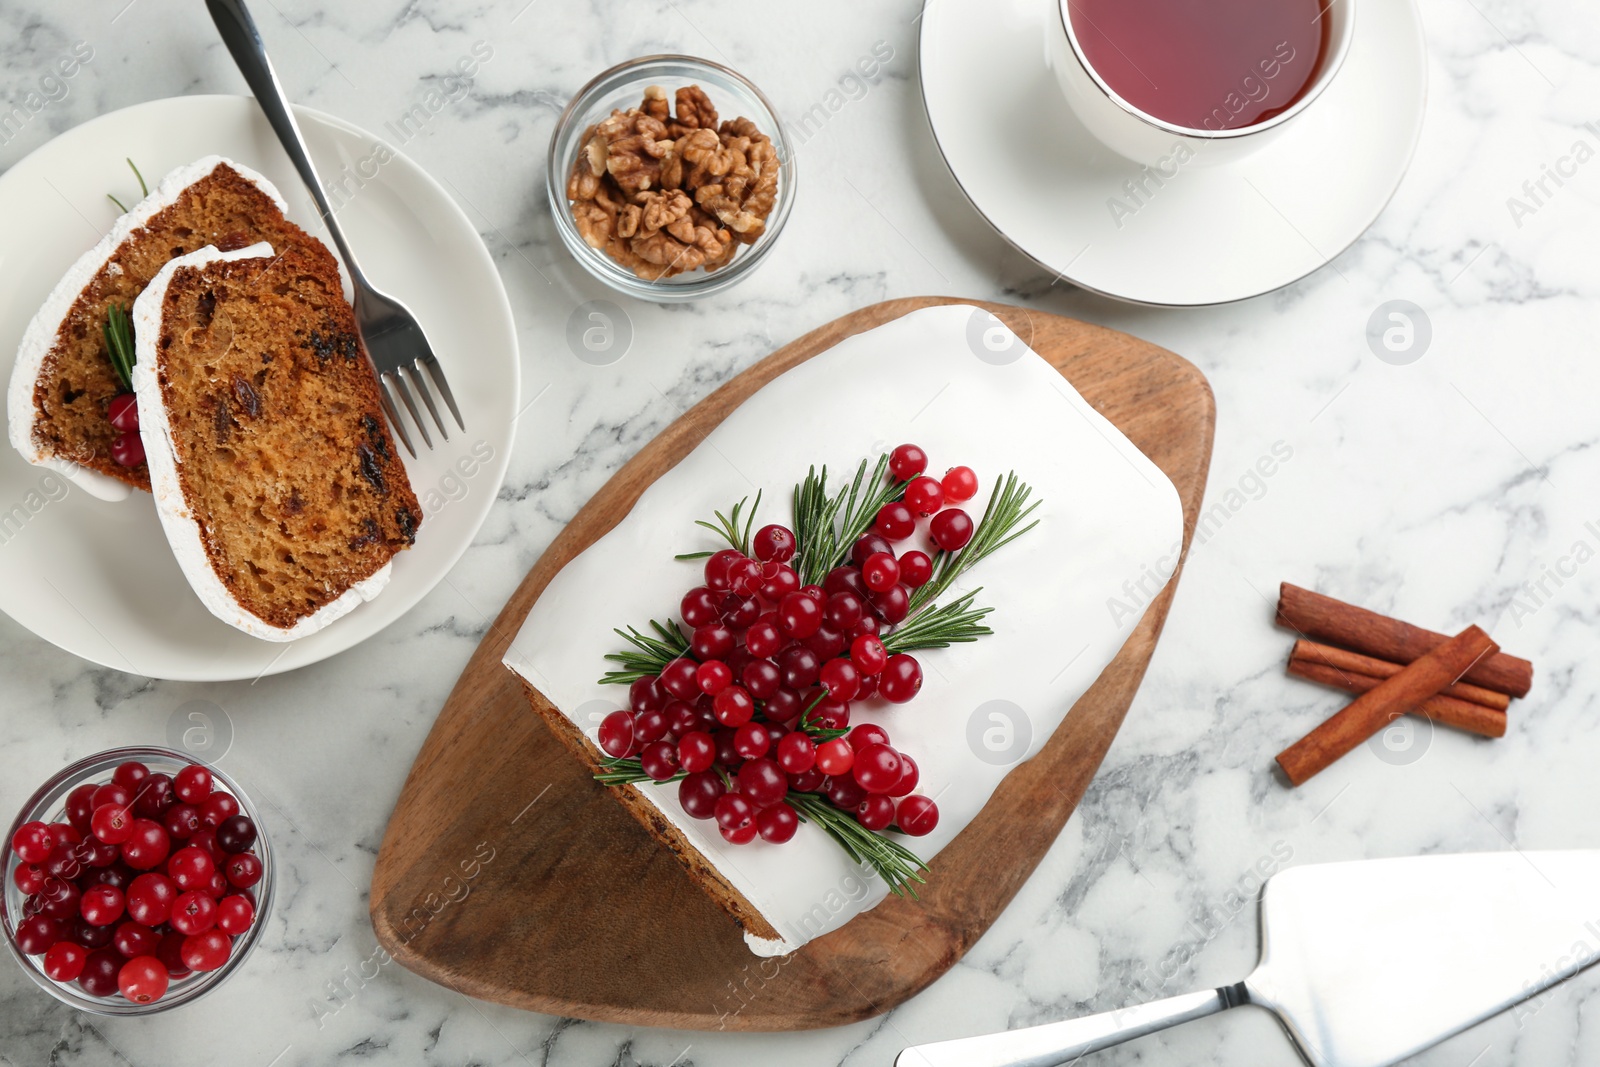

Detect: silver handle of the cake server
894,982,1248,1067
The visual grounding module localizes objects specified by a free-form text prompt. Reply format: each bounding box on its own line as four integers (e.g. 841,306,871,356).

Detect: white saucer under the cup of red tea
920,0,1427,306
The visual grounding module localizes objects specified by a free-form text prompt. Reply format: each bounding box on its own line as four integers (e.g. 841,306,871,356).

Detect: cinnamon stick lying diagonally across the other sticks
1278,625,1499,785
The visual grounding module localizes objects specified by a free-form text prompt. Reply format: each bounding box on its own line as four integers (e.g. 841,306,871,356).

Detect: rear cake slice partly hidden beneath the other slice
6,155,318,490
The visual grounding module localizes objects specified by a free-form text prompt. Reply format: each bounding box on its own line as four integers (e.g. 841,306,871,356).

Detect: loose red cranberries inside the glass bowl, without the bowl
11,761,262,1005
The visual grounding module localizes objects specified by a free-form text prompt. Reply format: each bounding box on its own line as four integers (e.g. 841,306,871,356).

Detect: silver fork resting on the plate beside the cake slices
206,0,467,458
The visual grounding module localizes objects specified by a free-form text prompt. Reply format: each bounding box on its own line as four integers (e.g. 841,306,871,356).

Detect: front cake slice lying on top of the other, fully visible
133,242,422,641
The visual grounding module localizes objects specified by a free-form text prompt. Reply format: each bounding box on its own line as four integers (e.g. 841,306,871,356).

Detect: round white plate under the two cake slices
0,96,520,681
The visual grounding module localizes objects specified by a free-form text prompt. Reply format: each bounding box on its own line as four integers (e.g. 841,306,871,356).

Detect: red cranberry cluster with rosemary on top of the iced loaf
600,445,978,845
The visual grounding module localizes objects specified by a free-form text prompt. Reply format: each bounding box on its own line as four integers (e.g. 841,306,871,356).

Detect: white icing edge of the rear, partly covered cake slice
6,155,288,502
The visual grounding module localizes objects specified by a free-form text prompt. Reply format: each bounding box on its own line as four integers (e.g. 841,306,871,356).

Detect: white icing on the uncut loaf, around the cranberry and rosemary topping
506,306,1182,955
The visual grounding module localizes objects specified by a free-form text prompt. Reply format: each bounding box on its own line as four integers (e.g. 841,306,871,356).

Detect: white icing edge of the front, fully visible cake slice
133,242,392,641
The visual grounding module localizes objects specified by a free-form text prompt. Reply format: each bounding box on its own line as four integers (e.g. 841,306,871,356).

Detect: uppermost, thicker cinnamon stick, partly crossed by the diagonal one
1278,582,1533,696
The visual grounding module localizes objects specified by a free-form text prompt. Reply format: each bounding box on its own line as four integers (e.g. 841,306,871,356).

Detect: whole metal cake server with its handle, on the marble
894,849,1600,1067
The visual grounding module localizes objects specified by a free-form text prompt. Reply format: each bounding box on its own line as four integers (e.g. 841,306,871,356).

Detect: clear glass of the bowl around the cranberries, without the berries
0,749,274,1016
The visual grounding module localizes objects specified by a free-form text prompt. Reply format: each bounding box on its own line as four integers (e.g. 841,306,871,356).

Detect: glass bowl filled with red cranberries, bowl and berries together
0,747,272,1016
